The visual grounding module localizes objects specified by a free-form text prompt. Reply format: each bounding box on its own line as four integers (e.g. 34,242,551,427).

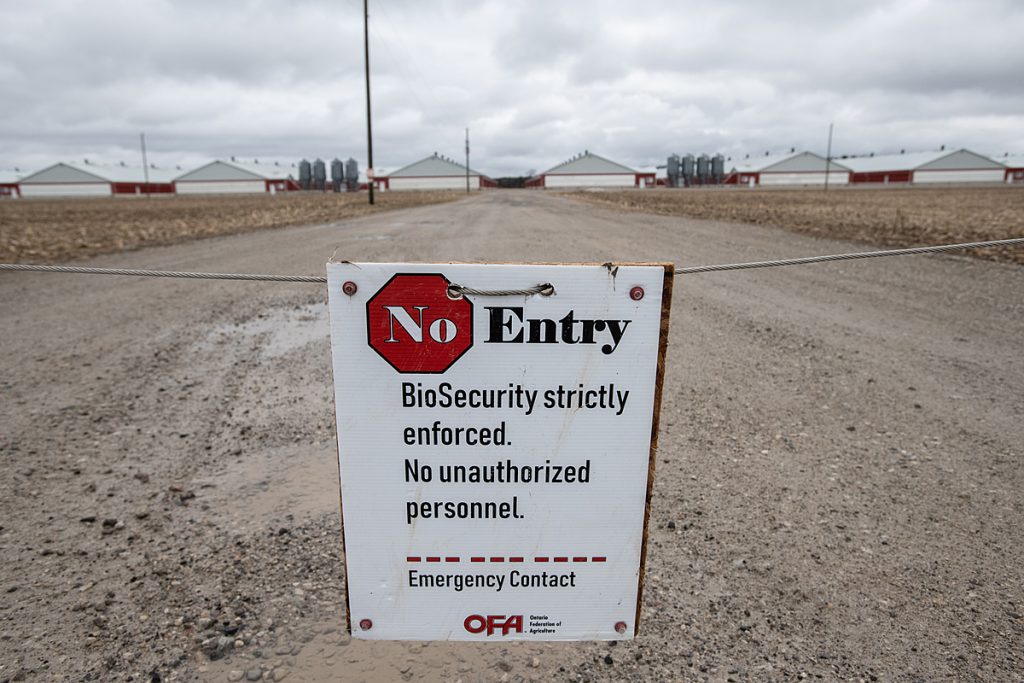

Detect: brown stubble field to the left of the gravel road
0,191,465,263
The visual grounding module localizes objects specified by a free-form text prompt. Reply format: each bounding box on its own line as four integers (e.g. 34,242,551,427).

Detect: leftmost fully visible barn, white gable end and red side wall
17,163,174,197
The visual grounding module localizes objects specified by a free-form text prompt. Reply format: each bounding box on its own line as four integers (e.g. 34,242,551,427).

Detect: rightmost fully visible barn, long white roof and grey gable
842,150,1006,184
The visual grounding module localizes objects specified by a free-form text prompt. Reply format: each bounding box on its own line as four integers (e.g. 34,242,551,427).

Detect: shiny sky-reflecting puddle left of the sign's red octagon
197,303,331,358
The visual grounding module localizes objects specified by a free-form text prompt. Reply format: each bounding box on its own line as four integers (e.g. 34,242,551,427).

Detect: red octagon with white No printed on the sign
367,273,473,374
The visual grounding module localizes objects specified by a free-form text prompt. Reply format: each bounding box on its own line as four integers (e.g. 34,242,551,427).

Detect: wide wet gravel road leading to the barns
0,191,1024,683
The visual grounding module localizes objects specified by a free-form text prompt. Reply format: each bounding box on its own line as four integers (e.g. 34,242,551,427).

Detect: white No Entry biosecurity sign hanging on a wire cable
328,263,673,641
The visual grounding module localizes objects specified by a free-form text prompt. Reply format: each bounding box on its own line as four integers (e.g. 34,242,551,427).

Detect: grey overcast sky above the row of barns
0,0,1024,176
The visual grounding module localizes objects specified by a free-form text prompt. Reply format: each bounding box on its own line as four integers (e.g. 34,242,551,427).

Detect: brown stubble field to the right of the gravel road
568,186,1024,263
